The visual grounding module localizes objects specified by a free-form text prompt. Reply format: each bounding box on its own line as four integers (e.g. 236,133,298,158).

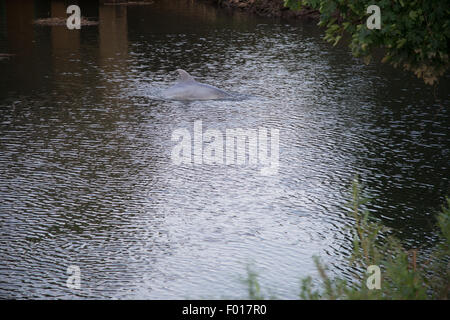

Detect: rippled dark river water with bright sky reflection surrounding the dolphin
0,0,450,299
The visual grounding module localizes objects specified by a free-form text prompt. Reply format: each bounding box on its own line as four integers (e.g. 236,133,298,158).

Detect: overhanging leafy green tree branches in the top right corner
285,0,450,85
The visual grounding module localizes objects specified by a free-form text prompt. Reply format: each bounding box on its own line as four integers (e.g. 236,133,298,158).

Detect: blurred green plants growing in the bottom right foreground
300,179,450,300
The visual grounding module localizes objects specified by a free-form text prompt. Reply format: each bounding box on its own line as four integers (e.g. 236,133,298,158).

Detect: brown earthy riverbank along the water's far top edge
203,0,320,20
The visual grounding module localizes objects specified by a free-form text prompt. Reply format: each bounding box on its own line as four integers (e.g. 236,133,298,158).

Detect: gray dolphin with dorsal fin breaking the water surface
163,69,230,100
